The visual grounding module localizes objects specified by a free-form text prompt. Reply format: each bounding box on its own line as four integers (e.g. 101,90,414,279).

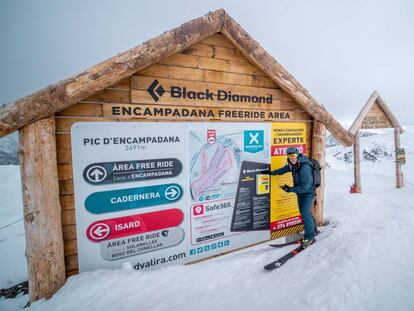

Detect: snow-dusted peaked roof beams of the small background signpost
349,91,404,135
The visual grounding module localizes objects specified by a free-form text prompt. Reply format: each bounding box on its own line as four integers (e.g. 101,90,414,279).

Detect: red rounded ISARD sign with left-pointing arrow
86,208,184,242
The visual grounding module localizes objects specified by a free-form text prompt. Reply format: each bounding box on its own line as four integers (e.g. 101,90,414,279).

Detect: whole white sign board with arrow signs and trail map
71,122,270,272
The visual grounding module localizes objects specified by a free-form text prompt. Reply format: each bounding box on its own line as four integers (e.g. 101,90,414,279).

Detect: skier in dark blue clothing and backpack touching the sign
270,147,319,248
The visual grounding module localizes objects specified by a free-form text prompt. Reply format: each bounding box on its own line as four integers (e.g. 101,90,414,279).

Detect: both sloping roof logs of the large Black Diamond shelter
0,9,353,146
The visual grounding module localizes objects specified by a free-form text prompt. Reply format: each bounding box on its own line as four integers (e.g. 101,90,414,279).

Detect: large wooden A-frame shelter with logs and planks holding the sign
0,9,353,301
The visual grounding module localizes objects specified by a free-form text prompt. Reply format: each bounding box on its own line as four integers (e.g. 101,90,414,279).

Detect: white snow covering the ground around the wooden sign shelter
0,127,414,311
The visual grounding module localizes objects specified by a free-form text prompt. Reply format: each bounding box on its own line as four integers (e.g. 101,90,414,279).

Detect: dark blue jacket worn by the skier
270,154,316,195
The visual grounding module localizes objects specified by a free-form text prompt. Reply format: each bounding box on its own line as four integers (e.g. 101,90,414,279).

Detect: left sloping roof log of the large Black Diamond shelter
0,9,224,137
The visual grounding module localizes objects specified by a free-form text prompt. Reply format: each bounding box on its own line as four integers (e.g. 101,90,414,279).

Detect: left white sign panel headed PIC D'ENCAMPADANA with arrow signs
71,122,188,272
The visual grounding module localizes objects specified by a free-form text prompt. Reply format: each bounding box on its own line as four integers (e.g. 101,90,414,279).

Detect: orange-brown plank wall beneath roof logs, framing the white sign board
55,34,312,276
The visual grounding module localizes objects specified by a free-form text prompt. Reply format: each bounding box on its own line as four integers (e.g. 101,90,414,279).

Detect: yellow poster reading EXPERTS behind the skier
270,122,307,239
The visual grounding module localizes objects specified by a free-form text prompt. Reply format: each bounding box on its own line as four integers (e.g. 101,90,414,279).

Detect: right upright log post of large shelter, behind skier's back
311,120,326,226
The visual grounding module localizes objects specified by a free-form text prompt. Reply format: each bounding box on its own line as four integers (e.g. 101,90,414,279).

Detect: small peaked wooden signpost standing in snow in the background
349,91,405,193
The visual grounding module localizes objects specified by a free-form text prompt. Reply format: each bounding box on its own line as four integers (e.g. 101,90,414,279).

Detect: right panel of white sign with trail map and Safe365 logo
188,123,270,261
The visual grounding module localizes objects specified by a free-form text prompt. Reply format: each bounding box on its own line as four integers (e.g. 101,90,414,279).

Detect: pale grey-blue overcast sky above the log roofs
0,0,414,127
